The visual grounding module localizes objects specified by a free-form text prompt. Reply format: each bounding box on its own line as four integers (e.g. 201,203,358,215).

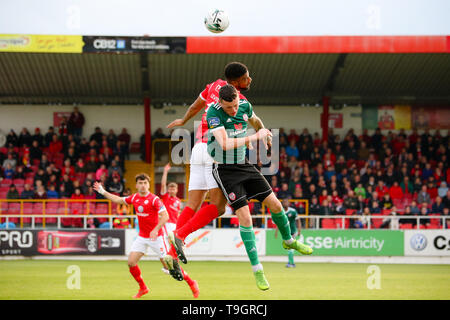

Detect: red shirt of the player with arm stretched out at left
124,192,166,238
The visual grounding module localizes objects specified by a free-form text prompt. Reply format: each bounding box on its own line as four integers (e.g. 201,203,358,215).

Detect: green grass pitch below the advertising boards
0,260,450,300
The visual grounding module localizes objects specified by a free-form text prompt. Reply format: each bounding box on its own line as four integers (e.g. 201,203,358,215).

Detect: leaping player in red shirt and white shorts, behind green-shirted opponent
167,62,256,263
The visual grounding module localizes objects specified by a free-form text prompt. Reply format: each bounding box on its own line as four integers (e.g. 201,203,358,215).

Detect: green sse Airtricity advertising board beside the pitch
266,230,404,256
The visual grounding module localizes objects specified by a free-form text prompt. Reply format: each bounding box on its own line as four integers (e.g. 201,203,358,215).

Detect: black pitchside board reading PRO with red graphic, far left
0,230,125,256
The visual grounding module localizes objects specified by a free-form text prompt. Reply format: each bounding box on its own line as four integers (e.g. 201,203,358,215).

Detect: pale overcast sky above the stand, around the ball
0,0,450,36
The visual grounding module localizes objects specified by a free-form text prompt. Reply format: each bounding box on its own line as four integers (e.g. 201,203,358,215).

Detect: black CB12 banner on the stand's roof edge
83,36,186,53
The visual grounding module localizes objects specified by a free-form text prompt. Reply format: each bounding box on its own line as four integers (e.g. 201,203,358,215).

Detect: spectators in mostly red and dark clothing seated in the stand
0,114,450,228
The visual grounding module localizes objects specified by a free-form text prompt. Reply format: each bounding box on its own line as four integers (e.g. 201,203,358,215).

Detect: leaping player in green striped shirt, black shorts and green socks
206,85,312,290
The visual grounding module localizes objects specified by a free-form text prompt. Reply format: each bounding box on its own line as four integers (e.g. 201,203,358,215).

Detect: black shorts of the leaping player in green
212,163,272,211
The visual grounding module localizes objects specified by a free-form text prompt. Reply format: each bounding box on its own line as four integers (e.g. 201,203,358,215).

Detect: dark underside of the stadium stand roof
0,52,450,105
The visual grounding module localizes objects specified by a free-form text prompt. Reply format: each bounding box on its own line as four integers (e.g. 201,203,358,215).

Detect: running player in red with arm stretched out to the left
94,173,198,298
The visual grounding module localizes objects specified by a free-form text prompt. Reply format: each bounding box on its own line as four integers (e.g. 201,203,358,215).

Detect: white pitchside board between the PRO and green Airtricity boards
125,229,266,257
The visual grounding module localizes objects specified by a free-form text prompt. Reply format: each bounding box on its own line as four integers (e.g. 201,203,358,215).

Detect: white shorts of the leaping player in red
188,143,219,191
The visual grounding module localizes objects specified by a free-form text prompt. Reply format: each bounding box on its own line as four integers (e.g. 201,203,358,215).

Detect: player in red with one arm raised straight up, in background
160,163,200,298
